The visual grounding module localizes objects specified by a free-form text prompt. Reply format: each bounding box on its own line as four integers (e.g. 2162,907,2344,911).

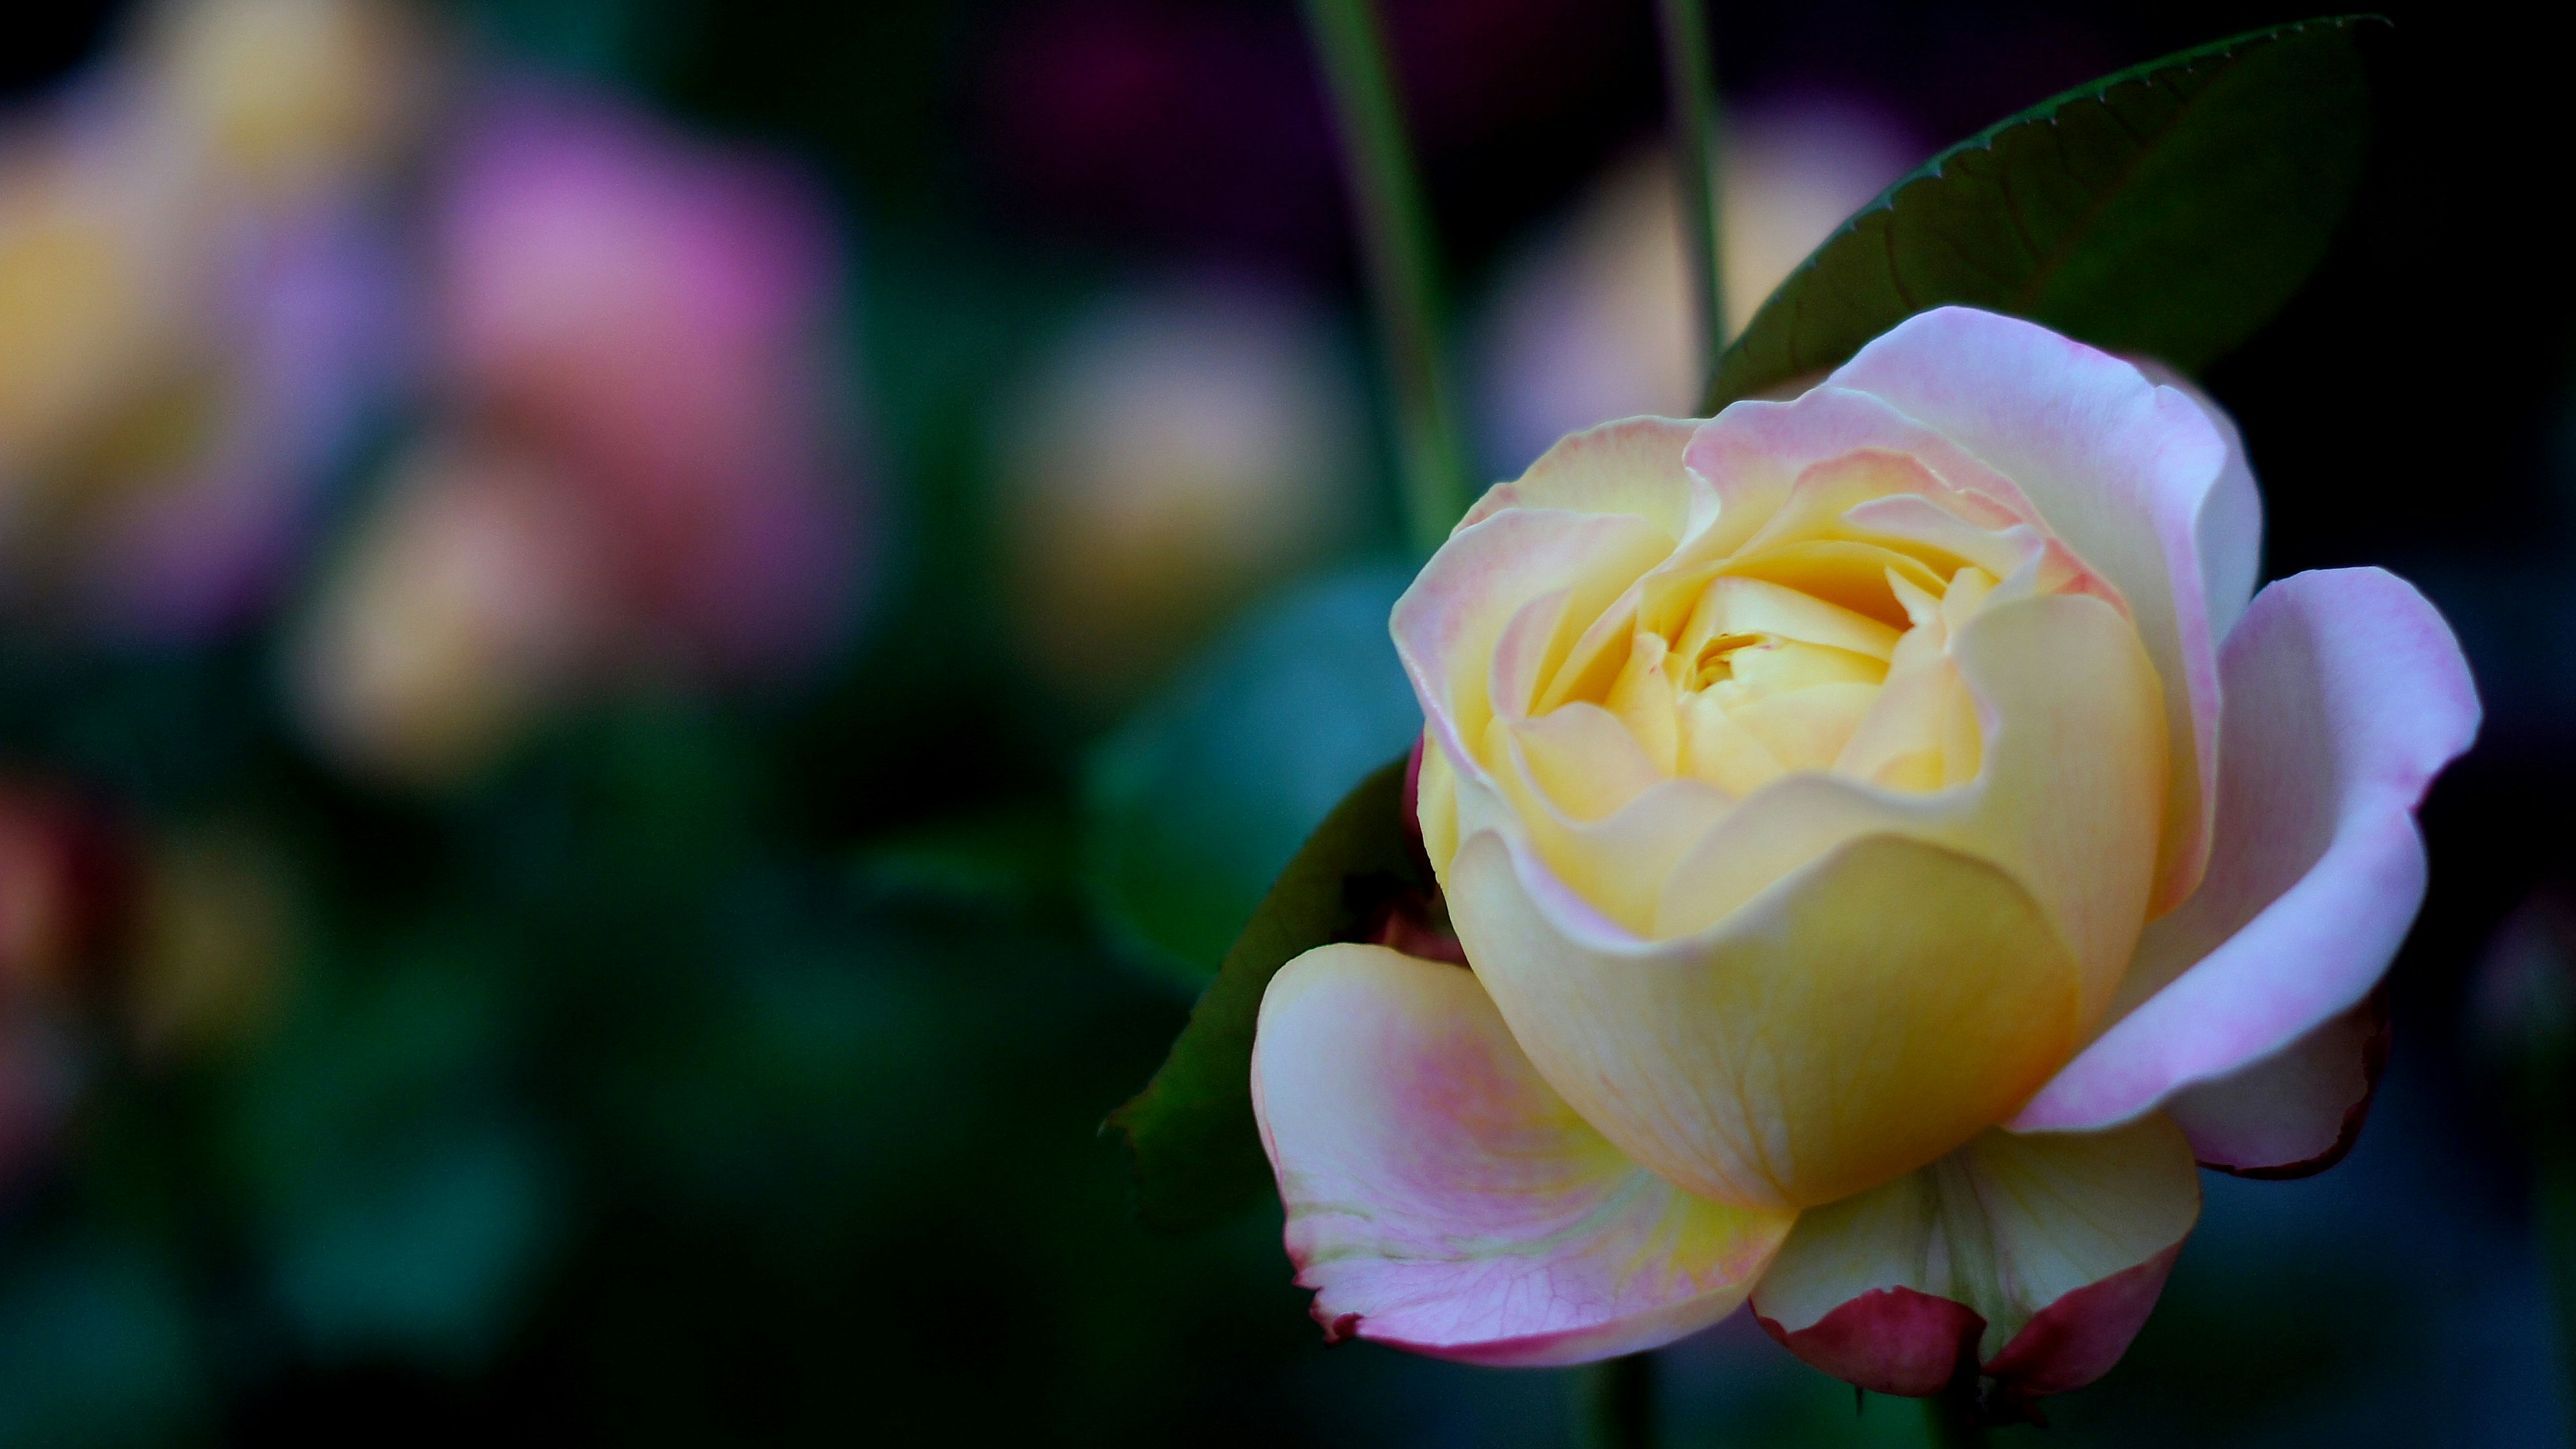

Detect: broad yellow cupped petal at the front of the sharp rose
1448,830,2082,1210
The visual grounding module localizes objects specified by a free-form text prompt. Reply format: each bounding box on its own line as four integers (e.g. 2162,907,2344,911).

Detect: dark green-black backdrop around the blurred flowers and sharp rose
0,0,2576,1446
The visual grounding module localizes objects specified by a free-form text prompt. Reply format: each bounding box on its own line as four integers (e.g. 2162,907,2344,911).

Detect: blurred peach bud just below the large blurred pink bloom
291,438,619,786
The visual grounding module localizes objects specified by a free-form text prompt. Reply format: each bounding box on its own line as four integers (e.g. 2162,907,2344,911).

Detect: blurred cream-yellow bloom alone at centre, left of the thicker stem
1000,281,1365,706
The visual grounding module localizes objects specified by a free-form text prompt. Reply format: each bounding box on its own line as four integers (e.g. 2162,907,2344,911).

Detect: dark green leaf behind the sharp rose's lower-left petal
1108,761,1430,1230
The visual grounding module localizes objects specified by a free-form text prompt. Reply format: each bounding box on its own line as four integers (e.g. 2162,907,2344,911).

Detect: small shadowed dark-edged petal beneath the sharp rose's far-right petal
2164,990,2388,1178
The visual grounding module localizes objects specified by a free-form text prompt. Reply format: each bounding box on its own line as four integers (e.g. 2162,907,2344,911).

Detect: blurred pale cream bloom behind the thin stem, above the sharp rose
1481,95,1922,472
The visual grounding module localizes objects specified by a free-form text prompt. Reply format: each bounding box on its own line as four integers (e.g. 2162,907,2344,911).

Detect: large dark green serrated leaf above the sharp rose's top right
1708,15,2370,413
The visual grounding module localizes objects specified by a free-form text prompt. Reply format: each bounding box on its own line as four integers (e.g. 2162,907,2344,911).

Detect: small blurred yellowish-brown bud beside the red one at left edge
126,828,304,1062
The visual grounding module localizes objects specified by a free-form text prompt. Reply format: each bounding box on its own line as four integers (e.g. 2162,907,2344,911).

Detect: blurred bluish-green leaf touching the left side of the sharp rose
1085,565,1422,990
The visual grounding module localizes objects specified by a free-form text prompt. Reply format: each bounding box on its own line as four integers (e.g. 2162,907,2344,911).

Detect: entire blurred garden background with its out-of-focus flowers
0,0,2576,1446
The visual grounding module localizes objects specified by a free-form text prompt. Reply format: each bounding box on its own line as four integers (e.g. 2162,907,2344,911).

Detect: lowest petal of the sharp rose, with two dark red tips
1754,1116,2200,1395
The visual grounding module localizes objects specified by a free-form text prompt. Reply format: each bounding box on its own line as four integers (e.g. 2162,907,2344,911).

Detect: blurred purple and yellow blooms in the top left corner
0,0,435,642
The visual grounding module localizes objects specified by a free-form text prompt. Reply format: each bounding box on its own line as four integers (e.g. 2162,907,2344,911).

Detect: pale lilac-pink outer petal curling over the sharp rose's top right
1827,307,2262,910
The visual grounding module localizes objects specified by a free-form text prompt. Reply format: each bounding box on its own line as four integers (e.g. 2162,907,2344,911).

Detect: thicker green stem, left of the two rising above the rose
1303,0,1468,554
